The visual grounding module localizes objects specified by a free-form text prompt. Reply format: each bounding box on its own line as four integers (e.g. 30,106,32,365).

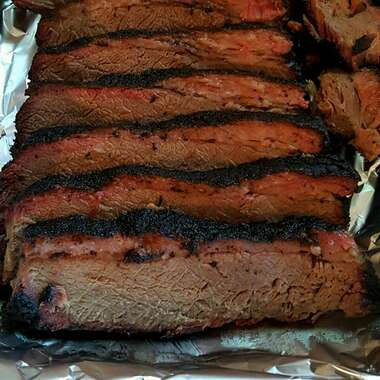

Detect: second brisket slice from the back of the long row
30,29,295,82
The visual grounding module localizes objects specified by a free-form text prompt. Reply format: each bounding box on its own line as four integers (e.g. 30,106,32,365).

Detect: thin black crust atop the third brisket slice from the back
30,68,307,88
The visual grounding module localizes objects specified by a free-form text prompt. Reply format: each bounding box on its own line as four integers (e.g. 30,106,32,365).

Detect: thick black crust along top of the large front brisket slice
23,209,340,251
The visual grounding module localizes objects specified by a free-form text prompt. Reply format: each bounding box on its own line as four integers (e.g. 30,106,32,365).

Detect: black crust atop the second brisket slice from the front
10,155,359,204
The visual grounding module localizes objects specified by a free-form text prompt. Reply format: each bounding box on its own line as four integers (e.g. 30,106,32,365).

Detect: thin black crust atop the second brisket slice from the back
37,22,290,54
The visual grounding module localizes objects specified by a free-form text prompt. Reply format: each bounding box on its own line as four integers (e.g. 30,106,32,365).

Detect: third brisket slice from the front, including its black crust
0,112,327,206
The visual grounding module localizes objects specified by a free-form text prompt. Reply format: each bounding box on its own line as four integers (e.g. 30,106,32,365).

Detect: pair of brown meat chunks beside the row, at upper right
307,0,380,161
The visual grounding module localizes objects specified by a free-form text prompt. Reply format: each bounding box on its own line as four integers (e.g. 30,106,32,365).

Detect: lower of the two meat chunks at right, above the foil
317,69,380,160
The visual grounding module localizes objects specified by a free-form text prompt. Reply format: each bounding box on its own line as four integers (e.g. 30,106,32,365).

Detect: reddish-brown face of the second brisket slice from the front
5,169,356,227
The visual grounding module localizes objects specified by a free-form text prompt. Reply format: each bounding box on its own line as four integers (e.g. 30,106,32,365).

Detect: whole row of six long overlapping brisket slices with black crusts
0,0,374,334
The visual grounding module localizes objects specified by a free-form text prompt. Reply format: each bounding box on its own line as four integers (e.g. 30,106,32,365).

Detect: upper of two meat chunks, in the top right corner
308,0,380,70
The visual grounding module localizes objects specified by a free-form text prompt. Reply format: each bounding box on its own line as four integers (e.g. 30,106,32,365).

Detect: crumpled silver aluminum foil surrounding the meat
0,5,380,380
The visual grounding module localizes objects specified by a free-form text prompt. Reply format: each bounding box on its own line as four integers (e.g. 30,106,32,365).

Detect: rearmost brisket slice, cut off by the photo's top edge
14,0,286,48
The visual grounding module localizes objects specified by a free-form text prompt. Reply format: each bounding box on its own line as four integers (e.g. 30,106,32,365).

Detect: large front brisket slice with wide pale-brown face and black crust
7,210,373,335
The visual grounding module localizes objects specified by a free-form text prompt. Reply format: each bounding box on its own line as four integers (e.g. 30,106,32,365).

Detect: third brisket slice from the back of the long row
17,71,309,140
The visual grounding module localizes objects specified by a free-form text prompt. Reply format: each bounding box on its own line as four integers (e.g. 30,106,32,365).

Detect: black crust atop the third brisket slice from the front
20,111,330,149
